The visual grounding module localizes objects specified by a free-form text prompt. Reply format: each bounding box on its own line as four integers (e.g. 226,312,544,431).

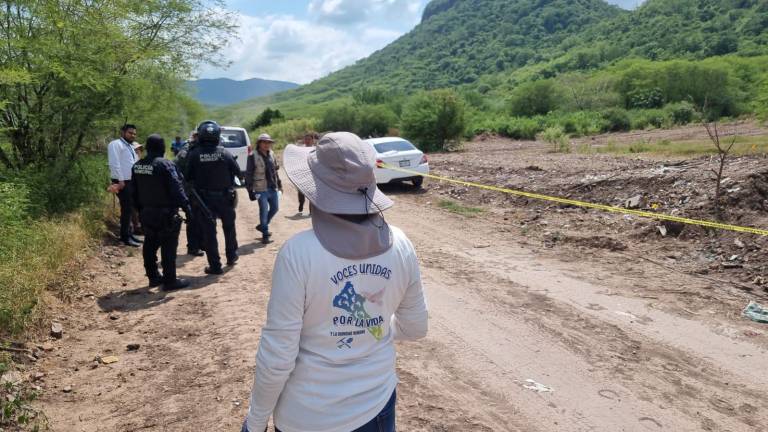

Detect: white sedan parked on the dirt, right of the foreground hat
365,137,429,188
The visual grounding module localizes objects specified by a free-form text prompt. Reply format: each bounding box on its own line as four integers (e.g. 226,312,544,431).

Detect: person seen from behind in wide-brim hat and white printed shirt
243,132,427,432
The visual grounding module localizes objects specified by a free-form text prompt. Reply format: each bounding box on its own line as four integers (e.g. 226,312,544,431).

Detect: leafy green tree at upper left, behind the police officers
0,0,234,169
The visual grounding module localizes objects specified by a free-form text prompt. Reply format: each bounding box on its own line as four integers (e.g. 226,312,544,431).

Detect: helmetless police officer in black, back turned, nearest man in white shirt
133,135,191,290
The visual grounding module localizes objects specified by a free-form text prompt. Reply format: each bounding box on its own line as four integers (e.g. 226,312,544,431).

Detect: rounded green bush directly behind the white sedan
402,90,465,151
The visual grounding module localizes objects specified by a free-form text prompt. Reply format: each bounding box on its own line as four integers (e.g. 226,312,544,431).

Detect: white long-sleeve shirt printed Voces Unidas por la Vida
247,227,427,432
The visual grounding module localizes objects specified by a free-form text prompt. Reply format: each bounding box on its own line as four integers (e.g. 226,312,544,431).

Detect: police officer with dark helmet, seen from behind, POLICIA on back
184,121,242,274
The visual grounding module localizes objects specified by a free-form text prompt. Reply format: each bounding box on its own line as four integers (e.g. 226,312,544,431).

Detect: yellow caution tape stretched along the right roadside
378,163,768,236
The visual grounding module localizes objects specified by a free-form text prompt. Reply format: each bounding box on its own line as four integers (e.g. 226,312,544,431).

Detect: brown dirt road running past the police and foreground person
40,177,768,432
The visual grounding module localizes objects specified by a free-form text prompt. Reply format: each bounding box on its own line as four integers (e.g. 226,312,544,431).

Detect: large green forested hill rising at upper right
214,0,768,132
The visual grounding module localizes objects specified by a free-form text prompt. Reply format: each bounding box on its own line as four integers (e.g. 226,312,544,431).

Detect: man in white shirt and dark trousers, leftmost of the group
107,124,141,247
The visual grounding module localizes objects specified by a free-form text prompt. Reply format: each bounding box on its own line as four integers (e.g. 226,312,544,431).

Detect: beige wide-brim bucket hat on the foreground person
283,132,393,215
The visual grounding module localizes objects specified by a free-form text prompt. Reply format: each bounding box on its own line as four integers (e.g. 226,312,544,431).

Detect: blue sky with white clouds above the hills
200,0,640,84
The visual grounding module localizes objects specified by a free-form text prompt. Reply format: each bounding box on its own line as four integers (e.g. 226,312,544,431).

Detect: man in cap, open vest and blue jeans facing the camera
245,134,283,244
